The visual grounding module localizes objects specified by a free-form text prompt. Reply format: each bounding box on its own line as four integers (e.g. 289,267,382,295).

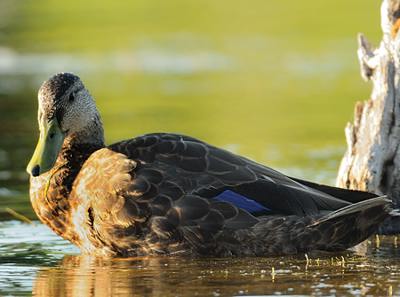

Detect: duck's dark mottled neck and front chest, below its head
30,119,105,243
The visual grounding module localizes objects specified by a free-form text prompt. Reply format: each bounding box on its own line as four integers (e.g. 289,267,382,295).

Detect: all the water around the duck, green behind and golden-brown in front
0,0,400,296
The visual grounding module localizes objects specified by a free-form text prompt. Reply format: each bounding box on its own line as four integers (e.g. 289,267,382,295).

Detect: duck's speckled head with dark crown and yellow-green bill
27,73,100,176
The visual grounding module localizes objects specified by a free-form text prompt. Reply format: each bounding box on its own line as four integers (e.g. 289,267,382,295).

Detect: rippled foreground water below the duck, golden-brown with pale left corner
0,221,400,296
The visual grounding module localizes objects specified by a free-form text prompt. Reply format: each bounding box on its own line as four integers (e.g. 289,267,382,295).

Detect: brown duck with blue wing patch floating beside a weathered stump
27,73,392,257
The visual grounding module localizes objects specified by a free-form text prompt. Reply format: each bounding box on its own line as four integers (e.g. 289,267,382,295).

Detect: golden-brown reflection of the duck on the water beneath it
32,244,399,297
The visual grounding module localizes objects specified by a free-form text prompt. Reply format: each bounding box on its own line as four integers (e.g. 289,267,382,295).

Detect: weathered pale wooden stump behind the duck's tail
337,0,400,231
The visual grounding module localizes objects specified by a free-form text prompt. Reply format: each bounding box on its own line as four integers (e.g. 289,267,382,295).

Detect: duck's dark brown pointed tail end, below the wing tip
299,196,393,251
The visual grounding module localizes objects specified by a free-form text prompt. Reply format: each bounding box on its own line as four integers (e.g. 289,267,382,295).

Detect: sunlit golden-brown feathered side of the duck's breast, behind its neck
70,148,148,254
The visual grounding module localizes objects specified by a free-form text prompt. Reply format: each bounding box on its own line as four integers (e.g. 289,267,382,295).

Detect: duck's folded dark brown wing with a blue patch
109,133,371,216
